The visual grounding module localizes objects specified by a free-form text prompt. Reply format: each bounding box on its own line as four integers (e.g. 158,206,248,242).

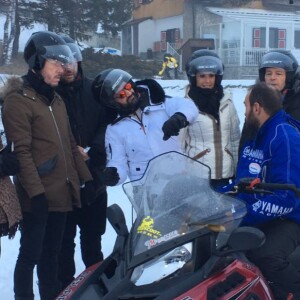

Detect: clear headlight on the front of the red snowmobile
131,243,192,286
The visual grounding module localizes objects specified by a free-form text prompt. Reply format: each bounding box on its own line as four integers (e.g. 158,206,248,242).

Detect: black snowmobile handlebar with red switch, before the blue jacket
233,178,300,197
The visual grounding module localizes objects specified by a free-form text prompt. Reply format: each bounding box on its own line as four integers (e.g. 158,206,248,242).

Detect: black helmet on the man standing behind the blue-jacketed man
258,49,298,87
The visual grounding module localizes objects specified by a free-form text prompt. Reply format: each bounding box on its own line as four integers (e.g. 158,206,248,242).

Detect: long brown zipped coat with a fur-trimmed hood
2,77,92,212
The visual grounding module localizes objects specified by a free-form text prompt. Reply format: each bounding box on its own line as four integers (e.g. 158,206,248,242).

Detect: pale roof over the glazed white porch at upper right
206,7,300,24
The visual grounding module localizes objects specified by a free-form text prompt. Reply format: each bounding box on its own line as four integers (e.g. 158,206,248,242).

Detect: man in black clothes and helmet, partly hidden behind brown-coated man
57,35,118,287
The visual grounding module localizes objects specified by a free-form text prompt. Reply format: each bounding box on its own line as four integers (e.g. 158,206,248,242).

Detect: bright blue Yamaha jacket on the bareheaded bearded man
236,110,300,225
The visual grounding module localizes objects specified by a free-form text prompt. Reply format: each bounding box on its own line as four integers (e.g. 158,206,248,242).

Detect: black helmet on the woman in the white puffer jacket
187,53,224,85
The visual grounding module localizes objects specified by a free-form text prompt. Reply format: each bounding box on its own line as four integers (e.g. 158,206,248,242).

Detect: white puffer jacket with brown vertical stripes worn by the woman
183,93,240,179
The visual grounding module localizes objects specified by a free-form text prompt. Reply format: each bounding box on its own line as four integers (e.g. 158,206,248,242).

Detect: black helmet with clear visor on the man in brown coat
24,31,74,70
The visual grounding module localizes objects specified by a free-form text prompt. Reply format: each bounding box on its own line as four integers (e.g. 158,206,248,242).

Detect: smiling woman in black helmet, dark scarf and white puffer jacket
183,50,240,189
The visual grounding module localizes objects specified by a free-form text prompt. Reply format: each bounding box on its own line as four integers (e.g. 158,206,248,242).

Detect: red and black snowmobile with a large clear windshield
56,152,298,300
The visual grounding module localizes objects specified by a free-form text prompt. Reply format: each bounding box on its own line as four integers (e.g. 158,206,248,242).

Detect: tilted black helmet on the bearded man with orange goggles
92,69,138,114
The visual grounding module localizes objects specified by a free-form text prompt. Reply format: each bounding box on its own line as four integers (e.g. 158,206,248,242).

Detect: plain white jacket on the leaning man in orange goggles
105,98,198,184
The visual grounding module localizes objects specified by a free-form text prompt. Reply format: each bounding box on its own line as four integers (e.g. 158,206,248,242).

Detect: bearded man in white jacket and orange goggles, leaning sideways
93,69,198,185
